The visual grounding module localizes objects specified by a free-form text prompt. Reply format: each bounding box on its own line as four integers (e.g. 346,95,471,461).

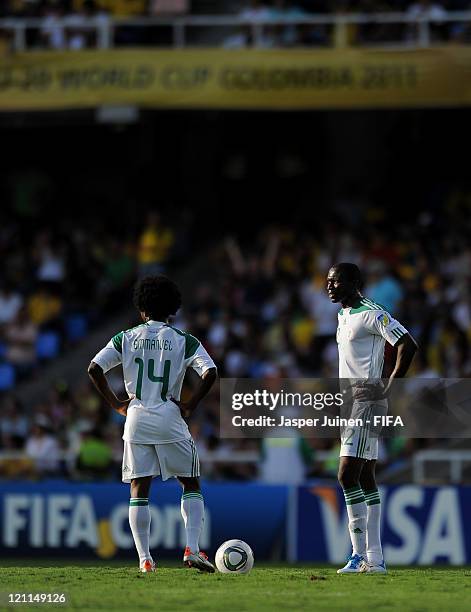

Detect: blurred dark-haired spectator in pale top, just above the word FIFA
25,416,60,476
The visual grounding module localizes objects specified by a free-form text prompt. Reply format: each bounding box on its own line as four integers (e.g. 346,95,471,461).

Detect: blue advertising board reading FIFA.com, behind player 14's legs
0,480,288,559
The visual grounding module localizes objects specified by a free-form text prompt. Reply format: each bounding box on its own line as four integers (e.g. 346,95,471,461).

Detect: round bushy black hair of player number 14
134,274,182,321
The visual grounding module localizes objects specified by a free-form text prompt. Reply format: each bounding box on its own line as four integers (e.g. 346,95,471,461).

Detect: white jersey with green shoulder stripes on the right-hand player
337,297,408,378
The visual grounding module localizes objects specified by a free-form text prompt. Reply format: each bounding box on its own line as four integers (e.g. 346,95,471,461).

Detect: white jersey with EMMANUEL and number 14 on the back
93,321,216,444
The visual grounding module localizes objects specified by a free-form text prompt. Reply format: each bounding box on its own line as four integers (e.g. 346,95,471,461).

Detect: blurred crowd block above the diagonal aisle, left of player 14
0,208,174,391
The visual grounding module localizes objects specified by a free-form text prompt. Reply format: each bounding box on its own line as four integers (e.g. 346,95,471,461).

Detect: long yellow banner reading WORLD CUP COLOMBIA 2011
0,46,471,111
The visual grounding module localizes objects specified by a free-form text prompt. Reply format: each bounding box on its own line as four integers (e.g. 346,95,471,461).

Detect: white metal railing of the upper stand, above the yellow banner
0,11,471,51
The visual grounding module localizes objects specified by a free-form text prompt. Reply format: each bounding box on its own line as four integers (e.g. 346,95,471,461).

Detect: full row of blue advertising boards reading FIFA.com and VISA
0,480,471,565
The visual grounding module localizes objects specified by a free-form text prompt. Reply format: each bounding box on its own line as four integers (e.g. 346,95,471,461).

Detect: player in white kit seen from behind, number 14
88,276,217,573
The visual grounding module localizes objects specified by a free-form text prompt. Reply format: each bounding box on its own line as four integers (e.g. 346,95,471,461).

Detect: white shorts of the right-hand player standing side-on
339,402,388,460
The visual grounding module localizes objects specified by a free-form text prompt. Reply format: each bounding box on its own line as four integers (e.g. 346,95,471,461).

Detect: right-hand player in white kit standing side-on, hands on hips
327,263,417,574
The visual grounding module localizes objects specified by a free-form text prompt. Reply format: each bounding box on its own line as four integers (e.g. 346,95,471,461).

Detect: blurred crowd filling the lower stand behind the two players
0,192,471,481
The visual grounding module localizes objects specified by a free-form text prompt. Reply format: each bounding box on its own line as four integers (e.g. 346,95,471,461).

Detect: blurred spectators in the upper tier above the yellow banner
0,0,471,49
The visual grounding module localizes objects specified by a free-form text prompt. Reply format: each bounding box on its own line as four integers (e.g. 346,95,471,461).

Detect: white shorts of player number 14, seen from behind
122,438,200,482
